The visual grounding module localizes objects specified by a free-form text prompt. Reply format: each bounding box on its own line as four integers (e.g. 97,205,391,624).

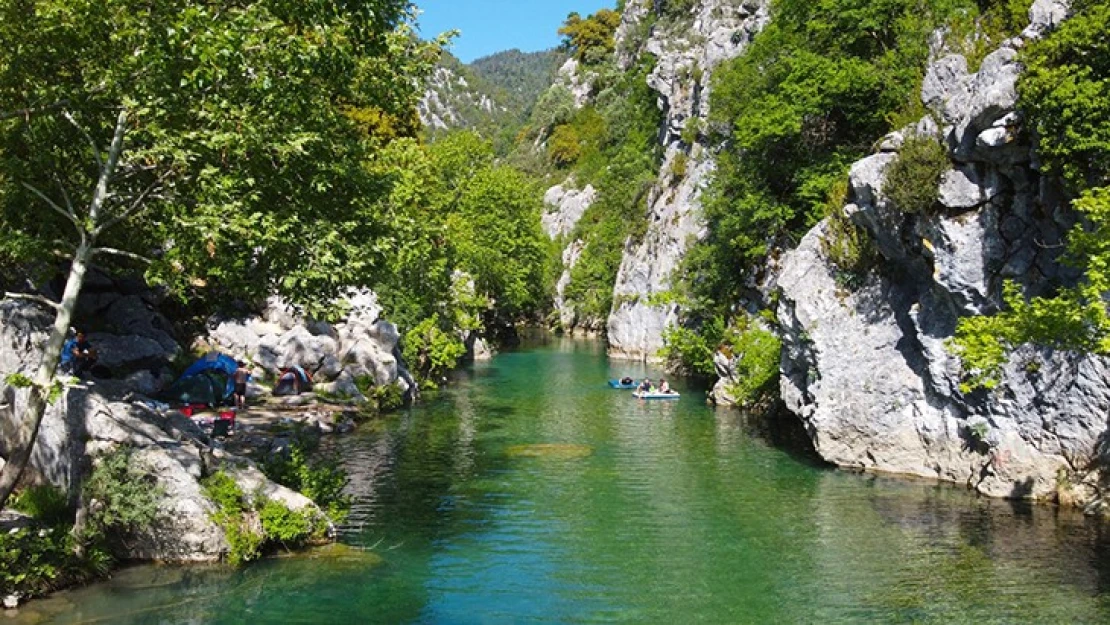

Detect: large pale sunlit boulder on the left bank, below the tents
0,301,320,562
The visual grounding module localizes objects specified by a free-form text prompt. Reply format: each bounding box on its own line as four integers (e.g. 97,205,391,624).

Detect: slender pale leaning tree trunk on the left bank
0,111,128,510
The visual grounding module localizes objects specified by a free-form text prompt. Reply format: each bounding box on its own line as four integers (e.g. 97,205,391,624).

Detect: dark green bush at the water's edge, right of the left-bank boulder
262,436,351,523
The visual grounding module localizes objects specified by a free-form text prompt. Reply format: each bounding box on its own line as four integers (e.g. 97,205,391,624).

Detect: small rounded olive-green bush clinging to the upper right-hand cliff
882,135,951,214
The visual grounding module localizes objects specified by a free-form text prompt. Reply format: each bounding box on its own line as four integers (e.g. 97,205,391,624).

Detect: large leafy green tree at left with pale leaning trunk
0,0,438,506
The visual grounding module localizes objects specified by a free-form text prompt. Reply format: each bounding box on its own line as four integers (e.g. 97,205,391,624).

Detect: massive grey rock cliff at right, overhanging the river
778,0,1110,503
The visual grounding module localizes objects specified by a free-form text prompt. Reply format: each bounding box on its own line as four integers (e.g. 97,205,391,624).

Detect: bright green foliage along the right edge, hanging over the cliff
949,1,1110,392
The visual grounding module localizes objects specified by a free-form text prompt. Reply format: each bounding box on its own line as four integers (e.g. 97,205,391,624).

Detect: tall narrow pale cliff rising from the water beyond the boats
607,0,769,360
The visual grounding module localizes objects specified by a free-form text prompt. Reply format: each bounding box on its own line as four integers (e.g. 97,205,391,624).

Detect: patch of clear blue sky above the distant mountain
416,0,616,63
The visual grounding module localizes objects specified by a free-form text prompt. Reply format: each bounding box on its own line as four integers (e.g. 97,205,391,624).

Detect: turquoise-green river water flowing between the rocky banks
21,340,1110,624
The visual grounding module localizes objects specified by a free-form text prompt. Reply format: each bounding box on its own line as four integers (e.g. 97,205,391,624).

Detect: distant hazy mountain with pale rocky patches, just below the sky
420,50,566,148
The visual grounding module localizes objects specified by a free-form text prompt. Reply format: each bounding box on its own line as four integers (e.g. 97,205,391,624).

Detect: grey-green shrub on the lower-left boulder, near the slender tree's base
83,446,163,540
